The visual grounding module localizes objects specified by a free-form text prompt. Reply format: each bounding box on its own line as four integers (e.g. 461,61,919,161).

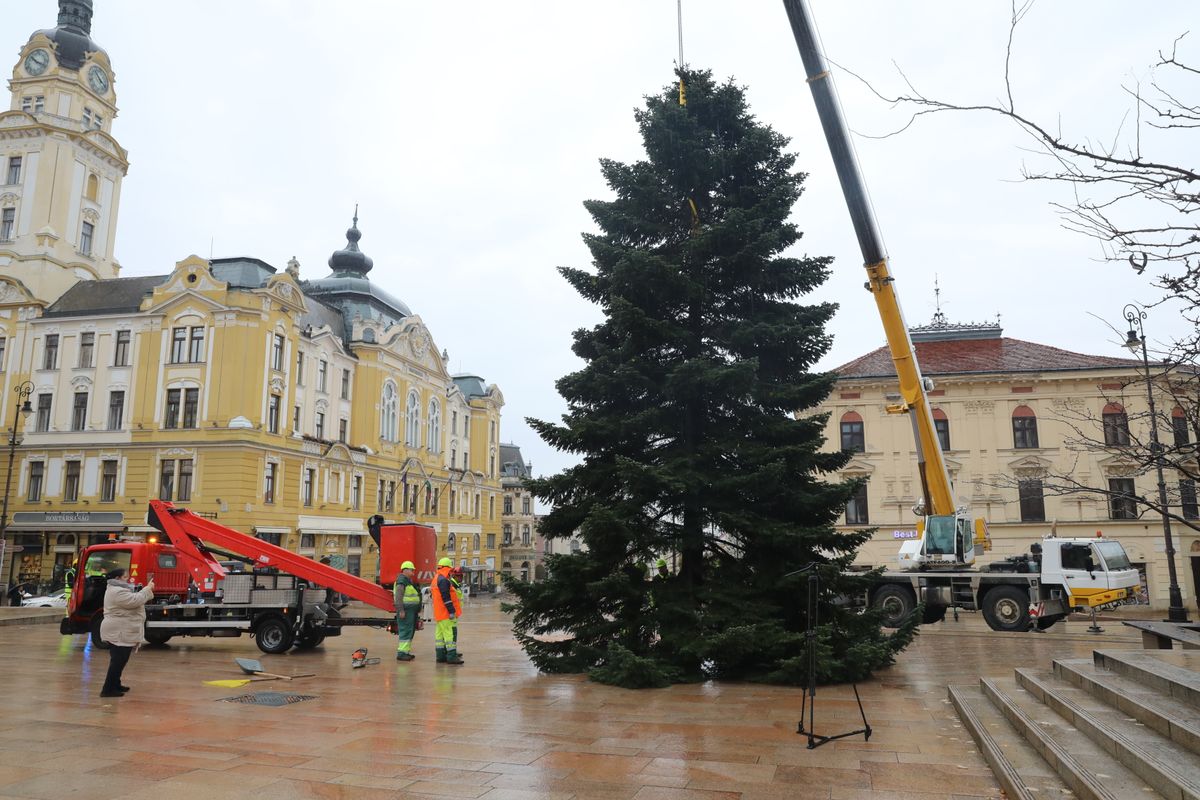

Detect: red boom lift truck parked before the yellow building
60,500,437,654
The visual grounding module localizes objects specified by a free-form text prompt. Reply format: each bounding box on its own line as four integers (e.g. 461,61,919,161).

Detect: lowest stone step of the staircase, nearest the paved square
947,686,1072,800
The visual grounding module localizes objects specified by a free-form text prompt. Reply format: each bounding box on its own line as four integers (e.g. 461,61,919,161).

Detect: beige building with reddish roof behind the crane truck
822,320,1200,609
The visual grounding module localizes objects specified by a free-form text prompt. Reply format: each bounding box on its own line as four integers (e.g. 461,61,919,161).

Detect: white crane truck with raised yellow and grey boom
784,0,1140,631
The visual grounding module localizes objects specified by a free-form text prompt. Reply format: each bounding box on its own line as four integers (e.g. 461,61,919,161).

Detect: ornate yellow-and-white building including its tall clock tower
0,0,504,590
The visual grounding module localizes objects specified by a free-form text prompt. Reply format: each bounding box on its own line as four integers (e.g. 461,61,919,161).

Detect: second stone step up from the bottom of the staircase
979,678,1163,800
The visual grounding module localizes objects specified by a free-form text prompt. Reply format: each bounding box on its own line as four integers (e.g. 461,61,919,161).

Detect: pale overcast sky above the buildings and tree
2,0,1200,482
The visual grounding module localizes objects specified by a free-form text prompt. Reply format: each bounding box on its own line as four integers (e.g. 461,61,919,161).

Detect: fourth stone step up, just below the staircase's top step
1054,658,1200,756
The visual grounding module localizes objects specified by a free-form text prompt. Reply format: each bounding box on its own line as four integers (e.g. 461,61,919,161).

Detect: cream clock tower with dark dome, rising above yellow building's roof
0,0,130,305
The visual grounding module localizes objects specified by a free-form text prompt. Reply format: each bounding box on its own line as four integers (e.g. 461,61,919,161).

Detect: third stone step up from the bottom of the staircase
1015,669,1200,800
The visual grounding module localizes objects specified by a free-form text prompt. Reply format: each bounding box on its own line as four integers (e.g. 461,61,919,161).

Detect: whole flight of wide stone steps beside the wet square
949,650,1200,800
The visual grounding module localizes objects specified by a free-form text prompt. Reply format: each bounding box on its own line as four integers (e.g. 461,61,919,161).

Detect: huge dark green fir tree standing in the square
509,70,912,686
